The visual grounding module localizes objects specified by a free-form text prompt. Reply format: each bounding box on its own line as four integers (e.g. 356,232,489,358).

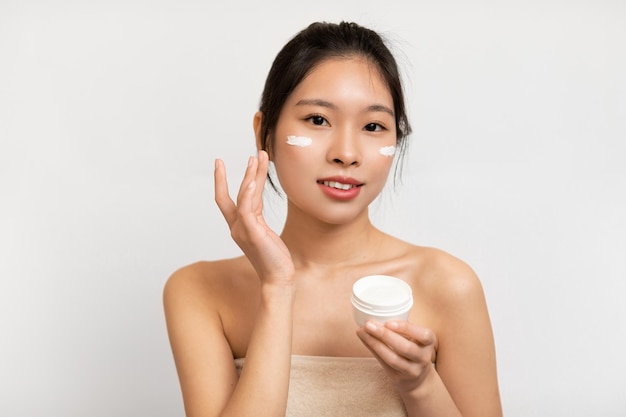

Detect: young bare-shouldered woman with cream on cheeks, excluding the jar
164,22,502,417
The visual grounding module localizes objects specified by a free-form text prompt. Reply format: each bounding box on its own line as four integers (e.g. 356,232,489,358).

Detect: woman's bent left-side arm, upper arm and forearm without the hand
164,266,293,417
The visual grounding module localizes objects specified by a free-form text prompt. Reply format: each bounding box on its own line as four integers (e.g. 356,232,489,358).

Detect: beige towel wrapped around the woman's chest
235,355,406,417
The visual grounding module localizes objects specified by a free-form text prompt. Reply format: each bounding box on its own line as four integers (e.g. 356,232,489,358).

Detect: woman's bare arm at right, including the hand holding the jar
358,252,502,417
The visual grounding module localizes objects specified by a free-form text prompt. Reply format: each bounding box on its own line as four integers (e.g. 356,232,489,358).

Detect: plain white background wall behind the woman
0,0,626,417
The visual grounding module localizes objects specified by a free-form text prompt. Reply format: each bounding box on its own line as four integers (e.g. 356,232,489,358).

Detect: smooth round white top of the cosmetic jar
352,275,413,313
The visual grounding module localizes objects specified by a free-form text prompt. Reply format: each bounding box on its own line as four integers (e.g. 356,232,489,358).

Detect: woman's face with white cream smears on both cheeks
271,58,396,224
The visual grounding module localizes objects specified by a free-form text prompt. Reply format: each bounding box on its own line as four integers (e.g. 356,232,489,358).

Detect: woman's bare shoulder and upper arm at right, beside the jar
390,239,502,416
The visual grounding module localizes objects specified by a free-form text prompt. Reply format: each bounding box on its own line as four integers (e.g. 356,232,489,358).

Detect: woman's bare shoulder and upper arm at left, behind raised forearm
163,258,258,415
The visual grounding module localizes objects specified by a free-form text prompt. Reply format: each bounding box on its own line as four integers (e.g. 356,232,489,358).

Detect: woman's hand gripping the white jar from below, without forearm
357,320,437,395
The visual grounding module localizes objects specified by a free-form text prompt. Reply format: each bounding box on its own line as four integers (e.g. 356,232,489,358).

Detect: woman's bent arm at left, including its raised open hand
164,151,295,417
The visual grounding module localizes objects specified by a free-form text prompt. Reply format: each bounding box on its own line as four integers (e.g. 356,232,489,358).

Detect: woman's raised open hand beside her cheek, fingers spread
215,151,295,285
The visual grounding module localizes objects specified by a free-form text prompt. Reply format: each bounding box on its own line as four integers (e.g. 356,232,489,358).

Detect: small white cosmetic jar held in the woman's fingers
350,275,413,326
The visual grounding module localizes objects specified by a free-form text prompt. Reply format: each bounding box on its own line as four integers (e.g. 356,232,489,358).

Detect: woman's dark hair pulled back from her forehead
259,22,411,188
